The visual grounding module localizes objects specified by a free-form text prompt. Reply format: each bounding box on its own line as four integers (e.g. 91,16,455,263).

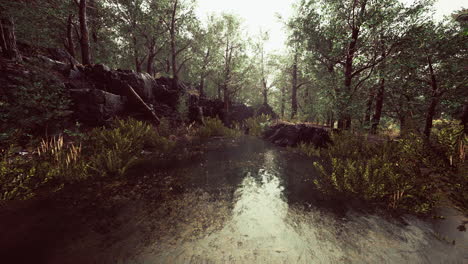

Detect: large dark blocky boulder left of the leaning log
70,89,127,125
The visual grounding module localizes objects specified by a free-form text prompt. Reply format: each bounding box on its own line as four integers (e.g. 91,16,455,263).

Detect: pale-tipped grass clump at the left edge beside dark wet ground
0,137,88,200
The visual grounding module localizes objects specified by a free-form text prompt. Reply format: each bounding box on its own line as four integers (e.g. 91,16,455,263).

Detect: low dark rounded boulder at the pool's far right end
264,123,331,147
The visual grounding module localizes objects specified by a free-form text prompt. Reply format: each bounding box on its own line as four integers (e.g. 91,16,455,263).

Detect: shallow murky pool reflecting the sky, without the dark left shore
130,138,468,263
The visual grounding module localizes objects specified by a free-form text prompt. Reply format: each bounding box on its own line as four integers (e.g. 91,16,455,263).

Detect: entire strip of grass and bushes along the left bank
0,119,175,200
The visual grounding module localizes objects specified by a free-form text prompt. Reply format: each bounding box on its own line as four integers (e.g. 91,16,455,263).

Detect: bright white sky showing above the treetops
196,0,468,52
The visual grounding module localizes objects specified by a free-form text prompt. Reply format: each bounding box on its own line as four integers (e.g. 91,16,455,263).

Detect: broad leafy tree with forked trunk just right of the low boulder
290,0,422,129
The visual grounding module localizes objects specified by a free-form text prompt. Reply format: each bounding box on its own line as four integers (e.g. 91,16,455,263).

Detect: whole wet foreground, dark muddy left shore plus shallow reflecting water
0,137,468,263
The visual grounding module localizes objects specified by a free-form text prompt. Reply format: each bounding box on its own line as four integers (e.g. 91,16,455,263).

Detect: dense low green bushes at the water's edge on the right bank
314,133,443,213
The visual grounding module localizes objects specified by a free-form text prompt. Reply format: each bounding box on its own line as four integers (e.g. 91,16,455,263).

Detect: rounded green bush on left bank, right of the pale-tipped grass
87,119,174,176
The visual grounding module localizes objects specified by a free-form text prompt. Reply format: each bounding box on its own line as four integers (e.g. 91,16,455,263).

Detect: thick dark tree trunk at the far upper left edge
0,18,22,62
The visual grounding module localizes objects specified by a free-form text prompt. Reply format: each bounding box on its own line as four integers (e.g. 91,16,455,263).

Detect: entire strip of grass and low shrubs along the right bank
297,127,468,213
